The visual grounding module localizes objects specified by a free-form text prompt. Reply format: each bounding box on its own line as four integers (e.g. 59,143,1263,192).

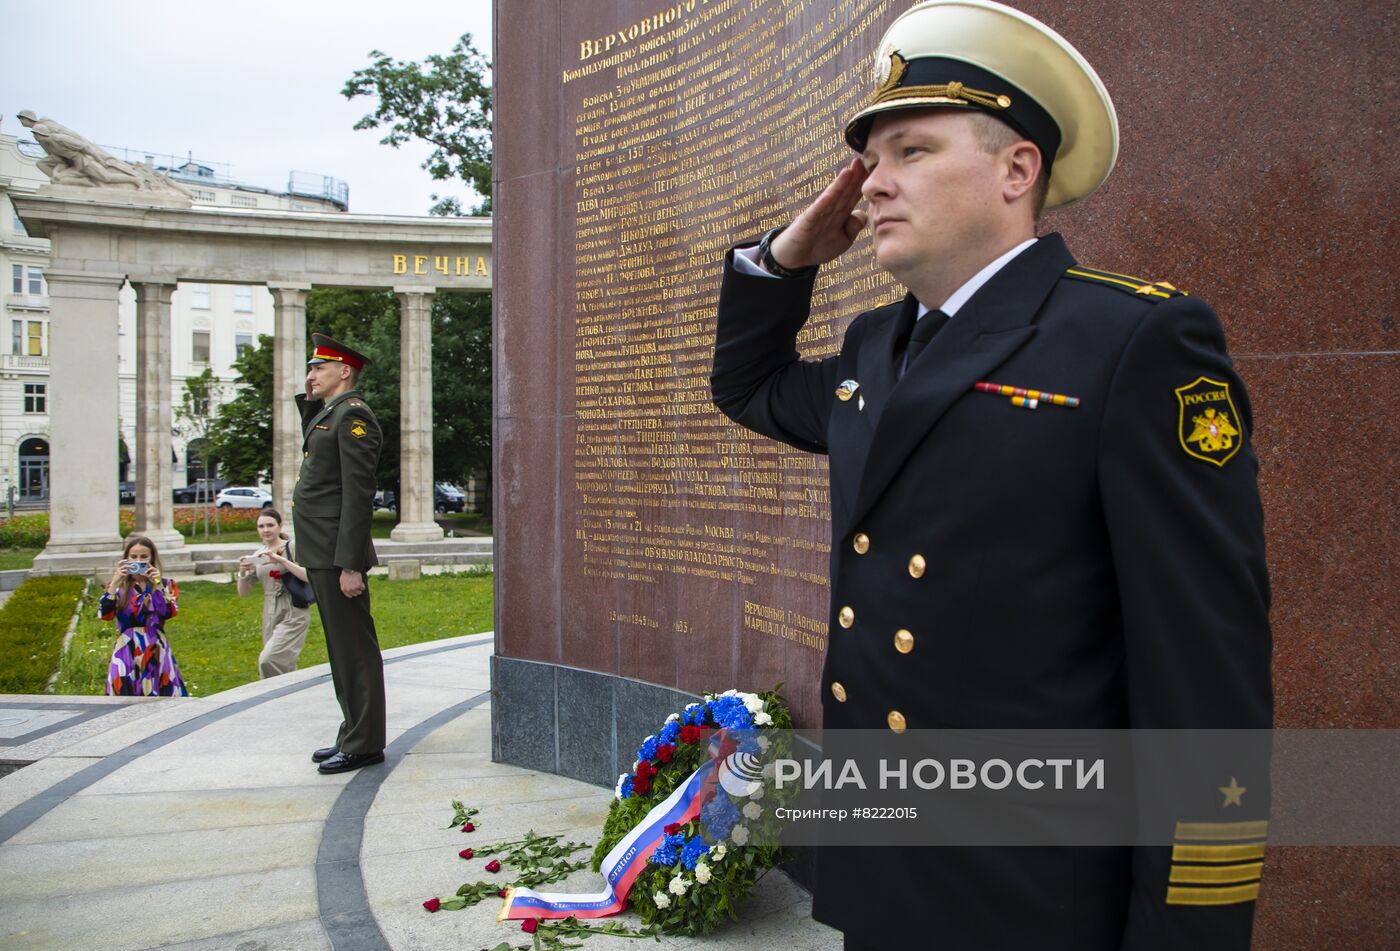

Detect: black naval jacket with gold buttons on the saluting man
711,234,1273,951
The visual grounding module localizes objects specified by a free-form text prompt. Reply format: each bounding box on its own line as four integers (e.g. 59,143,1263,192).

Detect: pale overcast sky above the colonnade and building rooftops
0,0,491,214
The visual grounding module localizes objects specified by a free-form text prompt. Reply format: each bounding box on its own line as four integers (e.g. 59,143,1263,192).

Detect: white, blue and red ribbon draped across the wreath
496,730,734,922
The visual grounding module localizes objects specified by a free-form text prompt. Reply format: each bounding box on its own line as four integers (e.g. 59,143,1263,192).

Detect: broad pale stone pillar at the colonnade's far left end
34,268,126,574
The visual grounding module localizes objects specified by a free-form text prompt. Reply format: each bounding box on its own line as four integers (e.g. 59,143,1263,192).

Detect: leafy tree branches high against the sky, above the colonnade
340,34,491,214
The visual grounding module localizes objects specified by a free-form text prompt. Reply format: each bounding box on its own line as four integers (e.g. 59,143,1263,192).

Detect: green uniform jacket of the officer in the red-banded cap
293,389,384,571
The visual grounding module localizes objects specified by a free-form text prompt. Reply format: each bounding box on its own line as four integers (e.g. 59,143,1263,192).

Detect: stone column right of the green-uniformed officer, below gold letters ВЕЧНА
392,287,442,542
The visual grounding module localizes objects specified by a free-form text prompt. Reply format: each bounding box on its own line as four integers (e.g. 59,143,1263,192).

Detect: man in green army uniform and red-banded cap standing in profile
293,333,385,773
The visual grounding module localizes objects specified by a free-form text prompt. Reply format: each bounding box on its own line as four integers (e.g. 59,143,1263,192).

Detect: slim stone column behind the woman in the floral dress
132,282,185,551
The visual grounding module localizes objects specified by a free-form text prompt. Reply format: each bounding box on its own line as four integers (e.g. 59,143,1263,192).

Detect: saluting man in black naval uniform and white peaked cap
711,0,1273,951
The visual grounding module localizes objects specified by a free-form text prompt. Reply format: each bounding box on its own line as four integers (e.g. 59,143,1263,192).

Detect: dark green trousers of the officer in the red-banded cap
307,569,385,754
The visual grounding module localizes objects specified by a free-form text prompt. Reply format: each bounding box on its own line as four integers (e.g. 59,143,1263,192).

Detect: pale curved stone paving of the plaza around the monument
0,634,840,951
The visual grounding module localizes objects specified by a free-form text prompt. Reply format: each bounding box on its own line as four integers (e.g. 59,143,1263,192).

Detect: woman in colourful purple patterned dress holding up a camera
98,535,189,696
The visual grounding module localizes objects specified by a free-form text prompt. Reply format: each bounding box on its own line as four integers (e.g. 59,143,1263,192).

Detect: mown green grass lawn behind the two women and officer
55,574,491,696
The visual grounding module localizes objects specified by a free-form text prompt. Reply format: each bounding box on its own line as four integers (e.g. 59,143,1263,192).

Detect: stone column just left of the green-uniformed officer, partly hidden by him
267,284,311,518
